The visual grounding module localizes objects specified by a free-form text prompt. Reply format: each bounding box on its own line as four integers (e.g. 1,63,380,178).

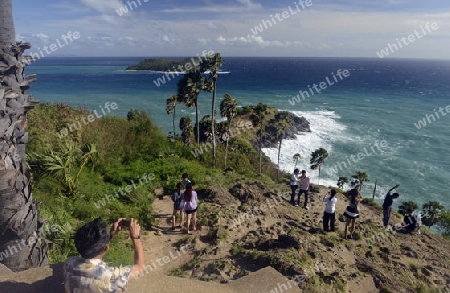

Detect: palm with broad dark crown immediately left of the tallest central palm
177,69,205,144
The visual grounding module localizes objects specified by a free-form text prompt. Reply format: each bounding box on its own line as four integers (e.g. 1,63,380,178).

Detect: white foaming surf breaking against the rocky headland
263,110,352,186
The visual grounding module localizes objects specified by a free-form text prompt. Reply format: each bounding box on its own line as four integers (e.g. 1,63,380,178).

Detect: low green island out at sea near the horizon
126,57,199,72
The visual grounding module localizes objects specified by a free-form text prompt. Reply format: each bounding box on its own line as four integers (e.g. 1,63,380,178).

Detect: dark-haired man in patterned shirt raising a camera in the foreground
64,218,144,293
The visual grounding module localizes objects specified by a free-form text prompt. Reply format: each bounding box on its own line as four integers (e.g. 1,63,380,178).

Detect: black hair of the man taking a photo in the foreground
75,218,110,259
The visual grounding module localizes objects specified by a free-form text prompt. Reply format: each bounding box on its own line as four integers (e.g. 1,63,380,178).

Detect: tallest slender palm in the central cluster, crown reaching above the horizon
200,53,222,168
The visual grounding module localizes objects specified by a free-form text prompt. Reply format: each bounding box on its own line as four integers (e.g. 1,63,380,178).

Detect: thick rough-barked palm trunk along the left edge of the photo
0,0,48,271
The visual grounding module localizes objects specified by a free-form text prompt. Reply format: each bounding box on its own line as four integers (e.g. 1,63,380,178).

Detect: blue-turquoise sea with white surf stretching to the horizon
26,57,450,212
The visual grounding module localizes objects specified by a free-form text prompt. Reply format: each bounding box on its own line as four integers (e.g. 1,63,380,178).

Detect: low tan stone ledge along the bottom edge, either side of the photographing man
0,264,302,293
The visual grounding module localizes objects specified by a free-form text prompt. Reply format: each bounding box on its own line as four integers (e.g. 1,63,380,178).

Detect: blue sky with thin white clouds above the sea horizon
12,0,450,59
